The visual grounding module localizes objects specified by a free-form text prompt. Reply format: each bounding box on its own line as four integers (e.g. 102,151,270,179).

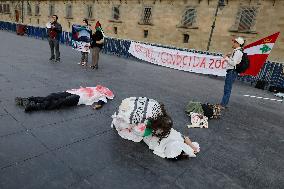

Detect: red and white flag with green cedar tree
241,32,280,76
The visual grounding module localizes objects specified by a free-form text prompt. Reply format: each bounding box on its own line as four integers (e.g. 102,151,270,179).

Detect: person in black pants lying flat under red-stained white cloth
15,85,114,112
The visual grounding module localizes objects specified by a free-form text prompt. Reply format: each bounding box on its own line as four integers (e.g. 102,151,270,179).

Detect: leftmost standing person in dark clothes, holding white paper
46,15,62,62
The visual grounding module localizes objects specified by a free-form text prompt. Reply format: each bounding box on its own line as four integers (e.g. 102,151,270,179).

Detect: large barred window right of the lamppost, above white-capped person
234,7,257,32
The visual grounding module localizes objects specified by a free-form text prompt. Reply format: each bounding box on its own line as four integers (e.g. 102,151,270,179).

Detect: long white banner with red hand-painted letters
128,42,227,76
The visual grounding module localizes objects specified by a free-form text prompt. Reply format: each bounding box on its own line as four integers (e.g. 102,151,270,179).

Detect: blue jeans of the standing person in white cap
221,70,238,107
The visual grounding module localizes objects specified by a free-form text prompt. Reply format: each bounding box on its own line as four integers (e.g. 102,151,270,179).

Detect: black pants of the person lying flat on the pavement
26,92,80,111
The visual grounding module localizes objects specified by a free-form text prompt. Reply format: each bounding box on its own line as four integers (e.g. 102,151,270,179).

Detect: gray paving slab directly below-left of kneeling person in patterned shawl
56,131,137,177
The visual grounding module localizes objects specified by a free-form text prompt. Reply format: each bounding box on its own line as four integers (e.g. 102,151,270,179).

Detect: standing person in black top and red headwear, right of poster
90,21,104,69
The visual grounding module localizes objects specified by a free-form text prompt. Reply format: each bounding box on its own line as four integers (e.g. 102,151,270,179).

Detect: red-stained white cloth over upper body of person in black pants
66,85,114,105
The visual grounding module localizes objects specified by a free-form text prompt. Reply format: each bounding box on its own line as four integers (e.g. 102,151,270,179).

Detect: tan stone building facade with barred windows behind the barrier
0,0,284,62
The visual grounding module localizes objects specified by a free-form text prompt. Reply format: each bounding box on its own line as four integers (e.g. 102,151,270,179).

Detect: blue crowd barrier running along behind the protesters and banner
0,21,284,88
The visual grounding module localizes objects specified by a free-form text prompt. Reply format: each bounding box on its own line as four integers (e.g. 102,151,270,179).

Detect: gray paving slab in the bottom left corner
0,154,79,189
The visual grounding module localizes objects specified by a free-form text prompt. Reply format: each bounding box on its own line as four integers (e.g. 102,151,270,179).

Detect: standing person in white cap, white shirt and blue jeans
220,37,245,109
